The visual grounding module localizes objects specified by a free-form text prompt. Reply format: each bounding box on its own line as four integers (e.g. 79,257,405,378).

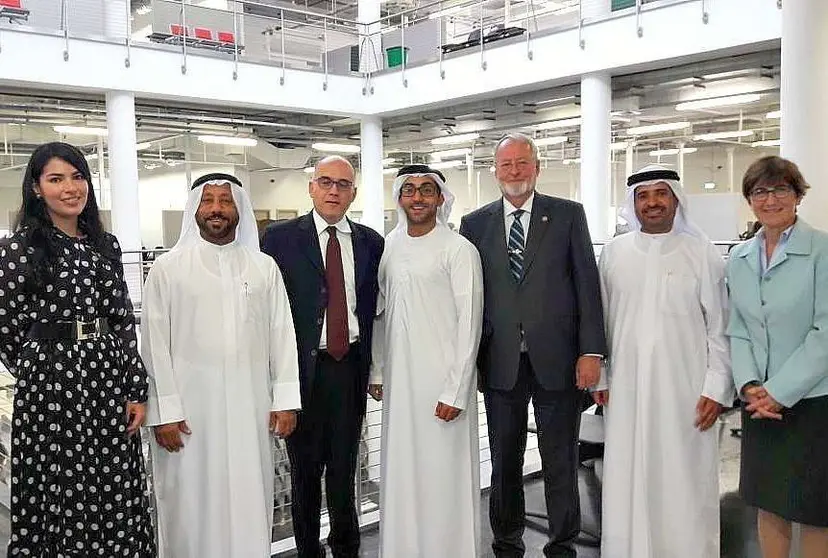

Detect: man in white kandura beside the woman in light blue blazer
593,165,735,558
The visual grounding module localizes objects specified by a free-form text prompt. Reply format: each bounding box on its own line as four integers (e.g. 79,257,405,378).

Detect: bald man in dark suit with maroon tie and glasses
262,157,384,558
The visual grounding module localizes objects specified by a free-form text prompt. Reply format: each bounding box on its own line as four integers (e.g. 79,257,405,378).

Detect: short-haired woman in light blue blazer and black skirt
727,157,828,558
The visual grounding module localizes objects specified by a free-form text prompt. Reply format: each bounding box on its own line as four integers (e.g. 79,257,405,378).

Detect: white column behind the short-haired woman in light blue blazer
781,0,828,229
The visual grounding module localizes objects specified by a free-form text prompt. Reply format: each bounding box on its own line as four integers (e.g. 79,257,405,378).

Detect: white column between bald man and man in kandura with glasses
359,116,385,235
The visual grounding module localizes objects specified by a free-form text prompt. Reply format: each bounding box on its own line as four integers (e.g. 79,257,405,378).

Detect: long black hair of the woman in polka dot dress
14,142,111,288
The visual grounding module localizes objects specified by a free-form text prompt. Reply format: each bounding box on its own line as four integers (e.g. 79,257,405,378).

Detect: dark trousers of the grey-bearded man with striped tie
484,354,584,558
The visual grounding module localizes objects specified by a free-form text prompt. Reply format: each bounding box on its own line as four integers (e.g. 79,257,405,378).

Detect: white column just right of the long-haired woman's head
106,91,143,305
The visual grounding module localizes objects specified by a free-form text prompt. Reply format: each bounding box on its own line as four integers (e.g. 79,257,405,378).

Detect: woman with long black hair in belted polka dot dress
0,143,156,558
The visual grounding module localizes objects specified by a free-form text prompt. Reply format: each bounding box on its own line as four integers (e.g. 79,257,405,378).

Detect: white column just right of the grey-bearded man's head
581,74,612,241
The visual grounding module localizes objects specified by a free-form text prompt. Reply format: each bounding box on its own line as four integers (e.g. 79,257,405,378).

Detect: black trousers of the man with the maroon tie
287,344,366,558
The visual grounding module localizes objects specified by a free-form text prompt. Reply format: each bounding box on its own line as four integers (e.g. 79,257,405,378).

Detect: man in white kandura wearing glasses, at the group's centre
369,165,483,558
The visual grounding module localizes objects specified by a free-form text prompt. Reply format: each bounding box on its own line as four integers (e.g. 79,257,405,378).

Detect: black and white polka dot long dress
0,230,156,558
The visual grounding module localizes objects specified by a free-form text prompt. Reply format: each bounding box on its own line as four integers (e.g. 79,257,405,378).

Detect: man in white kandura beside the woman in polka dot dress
142,174,300,558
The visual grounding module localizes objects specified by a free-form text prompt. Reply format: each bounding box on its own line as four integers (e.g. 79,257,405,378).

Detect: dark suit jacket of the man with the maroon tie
262,213,385,412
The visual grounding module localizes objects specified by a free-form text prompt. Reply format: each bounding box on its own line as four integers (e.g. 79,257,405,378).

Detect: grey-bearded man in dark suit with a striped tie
460,134,606,558
